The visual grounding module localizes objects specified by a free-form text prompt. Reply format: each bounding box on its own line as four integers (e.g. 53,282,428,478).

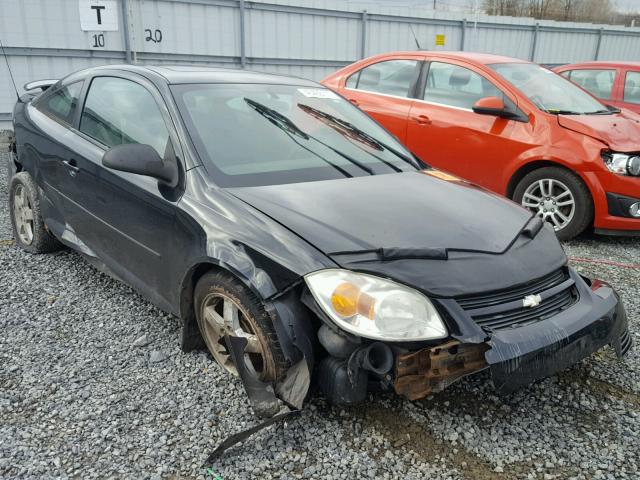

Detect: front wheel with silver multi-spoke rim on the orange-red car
513,167,593,240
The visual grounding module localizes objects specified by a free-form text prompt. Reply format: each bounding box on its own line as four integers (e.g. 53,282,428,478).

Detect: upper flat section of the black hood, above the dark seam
231,172,531,255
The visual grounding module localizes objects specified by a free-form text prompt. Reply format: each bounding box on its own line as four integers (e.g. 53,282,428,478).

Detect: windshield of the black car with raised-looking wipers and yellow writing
172,84,423,187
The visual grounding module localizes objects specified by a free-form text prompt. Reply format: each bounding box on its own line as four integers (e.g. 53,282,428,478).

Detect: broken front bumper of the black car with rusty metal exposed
319,272,631,403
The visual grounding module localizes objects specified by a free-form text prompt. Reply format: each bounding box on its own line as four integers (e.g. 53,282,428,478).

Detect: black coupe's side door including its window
68,74,183,310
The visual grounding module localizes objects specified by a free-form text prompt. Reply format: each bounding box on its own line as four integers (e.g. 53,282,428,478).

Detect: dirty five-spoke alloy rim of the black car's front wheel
202,293,269,379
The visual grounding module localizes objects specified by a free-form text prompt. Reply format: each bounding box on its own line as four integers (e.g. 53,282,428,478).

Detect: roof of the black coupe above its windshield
89,64,324,88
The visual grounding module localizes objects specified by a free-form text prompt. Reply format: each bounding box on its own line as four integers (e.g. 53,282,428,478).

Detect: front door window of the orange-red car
423,62,504,110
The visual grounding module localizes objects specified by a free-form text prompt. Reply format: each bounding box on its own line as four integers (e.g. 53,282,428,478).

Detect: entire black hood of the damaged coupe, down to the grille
230,172,566,296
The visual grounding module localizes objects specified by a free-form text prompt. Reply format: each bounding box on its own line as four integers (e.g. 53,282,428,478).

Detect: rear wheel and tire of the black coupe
9,172,62,253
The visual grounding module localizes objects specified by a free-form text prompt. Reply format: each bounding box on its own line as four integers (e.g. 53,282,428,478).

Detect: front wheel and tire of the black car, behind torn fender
194,272,288,382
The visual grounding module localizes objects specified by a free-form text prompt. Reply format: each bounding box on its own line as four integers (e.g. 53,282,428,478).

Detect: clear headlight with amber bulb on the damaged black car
305,269,447,341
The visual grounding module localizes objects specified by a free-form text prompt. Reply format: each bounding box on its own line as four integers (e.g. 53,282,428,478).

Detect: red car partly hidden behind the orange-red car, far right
553,62,640,113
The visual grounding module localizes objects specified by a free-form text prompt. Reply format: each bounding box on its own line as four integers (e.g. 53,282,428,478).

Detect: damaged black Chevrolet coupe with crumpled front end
9,66,631,414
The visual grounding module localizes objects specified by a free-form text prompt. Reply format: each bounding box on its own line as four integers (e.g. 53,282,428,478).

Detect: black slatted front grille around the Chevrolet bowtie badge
456,268,578,330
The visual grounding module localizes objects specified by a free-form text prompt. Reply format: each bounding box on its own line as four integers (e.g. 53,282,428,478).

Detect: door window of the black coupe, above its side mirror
80,77,169,157
